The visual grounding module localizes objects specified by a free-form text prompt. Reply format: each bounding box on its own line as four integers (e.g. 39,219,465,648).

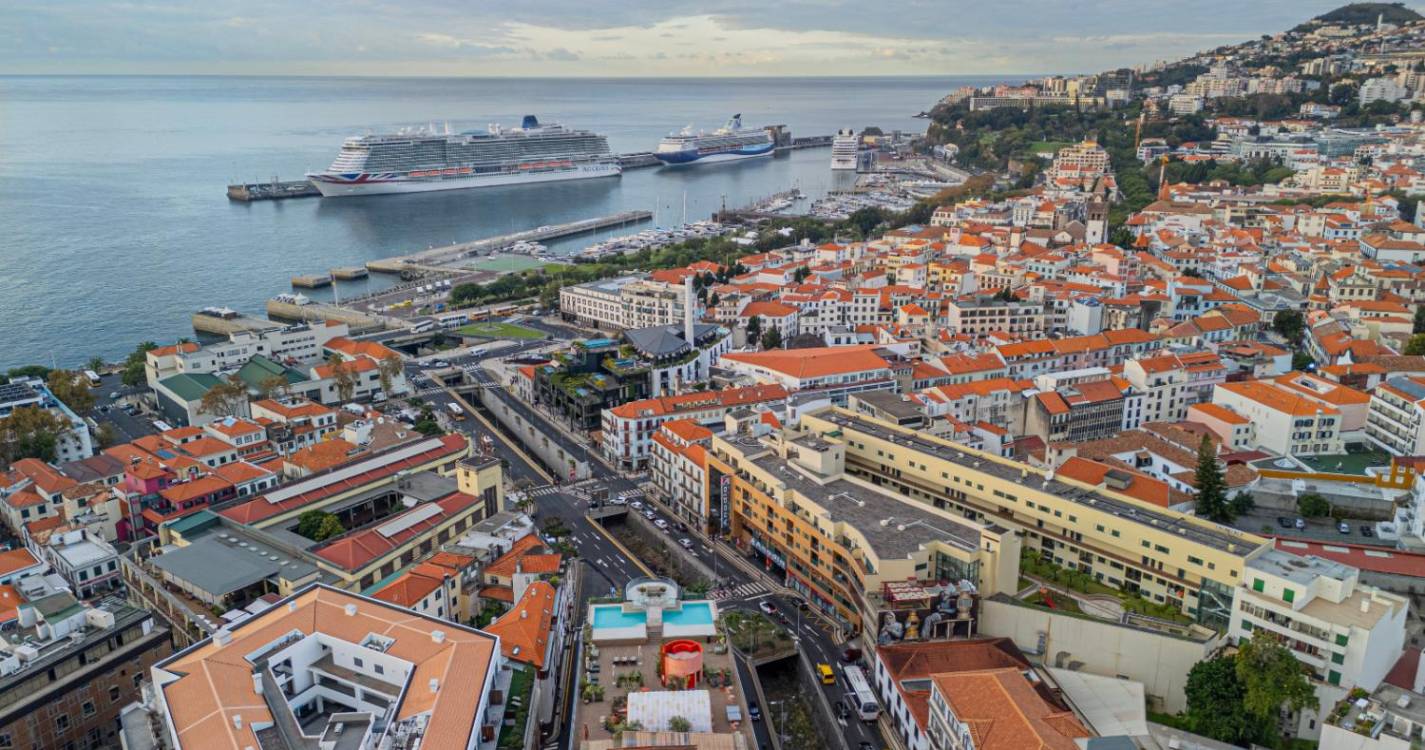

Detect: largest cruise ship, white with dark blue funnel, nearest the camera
306,115,623,198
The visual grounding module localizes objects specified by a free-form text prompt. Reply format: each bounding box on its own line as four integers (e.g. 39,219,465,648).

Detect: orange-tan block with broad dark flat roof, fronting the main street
707,430,1020,639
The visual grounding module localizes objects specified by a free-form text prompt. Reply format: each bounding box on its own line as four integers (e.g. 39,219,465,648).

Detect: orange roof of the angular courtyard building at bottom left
154,585,494,750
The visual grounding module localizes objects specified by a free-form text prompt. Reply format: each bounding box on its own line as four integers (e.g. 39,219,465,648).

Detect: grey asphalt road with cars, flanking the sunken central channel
428,382,884,747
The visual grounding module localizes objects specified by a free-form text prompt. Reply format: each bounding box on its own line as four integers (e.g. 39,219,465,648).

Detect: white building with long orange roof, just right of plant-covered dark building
600,384,787,469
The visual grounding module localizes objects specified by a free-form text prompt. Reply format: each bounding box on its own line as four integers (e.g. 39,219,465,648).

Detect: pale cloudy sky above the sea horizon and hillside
0,0,1414,77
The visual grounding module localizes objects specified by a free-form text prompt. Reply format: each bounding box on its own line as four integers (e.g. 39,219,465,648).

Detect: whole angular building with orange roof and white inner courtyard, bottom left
151,585,502,750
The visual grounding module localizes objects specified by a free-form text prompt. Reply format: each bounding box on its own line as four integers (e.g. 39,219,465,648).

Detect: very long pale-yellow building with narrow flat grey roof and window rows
799,409,1267,629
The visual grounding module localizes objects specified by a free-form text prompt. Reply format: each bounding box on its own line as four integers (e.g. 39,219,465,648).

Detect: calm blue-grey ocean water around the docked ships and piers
0,77,989,369
